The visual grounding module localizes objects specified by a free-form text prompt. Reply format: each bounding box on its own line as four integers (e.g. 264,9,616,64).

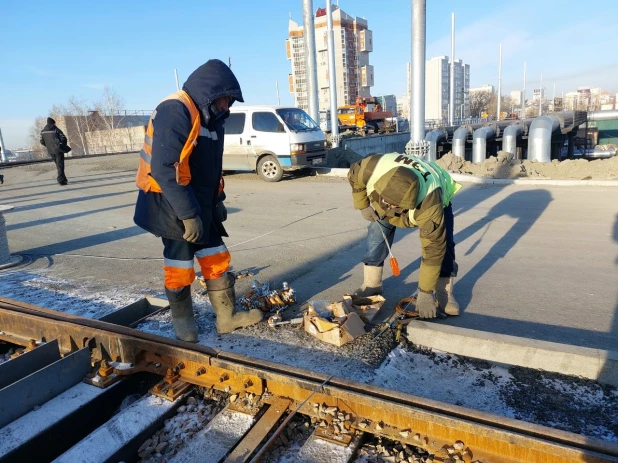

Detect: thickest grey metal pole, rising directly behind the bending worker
410,0,426,143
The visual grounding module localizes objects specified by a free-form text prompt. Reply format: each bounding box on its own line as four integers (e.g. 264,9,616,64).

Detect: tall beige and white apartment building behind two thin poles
285,5,374,111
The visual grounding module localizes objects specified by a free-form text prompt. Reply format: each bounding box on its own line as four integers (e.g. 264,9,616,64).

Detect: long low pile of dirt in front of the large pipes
438,151,618,180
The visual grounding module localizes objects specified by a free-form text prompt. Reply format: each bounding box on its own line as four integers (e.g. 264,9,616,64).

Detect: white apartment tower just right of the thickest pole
425,56,470,121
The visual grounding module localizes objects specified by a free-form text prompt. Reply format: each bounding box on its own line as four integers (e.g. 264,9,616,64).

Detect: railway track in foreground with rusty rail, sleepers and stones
0,298,618,463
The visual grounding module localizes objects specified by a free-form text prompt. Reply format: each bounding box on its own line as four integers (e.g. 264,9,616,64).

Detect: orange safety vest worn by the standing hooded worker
135,90,200,193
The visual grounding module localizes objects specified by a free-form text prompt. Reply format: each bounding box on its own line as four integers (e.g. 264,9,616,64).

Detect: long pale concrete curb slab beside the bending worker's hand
407,320,618,387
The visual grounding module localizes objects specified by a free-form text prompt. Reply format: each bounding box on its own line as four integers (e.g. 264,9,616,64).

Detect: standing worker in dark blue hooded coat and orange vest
134,60,262,342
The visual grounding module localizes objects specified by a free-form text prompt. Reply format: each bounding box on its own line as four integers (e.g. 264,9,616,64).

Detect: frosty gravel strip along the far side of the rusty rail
0,272,618,442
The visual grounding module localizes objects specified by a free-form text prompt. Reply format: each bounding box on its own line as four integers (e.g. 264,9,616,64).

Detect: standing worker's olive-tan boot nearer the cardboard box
206,273,262,334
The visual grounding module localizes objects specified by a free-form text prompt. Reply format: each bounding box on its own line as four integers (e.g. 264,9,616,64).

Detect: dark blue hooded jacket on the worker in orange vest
133,60,244,244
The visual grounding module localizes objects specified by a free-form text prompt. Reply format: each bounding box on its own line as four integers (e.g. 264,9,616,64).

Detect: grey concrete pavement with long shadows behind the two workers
0,155,618,350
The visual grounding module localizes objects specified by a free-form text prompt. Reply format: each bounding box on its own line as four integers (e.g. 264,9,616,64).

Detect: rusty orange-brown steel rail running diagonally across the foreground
0,297,618,463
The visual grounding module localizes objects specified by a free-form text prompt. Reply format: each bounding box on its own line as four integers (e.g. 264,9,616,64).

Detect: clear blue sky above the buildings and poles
0,0,618,149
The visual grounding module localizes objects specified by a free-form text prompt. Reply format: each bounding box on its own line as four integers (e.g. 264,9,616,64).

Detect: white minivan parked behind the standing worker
223,105,326,182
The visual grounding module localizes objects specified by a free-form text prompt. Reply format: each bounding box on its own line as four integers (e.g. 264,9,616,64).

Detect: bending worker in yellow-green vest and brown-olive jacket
348,153,461,318
